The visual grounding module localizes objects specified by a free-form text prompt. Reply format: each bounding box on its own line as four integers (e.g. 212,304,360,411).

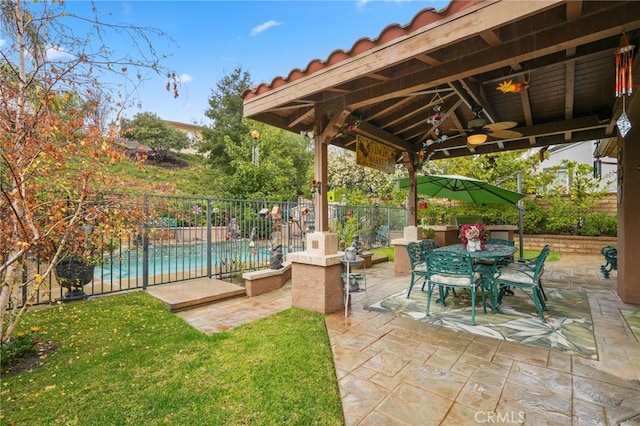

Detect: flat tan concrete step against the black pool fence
147,278,246,312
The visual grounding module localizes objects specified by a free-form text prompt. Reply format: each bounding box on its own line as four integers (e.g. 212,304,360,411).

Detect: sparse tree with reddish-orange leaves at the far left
0,0,177,343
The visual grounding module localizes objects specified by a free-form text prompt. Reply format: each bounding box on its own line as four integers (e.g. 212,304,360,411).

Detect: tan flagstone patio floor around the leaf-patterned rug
177,255,640,425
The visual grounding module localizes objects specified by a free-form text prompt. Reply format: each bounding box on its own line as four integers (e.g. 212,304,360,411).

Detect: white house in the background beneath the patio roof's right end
540,140,617,193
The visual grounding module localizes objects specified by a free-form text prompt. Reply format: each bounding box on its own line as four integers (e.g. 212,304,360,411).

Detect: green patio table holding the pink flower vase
434,244,517,313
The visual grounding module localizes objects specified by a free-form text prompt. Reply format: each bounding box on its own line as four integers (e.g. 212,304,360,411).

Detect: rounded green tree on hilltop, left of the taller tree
121,112,189,161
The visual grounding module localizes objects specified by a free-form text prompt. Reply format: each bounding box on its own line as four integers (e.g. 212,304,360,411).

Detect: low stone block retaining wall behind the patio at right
514,234,618,254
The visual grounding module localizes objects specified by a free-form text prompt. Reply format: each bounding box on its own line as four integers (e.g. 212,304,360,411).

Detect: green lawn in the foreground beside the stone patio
0,292,344,425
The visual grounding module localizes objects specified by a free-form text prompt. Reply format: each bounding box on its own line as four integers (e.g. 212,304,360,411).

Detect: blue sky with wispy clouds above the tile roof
55,0,449,125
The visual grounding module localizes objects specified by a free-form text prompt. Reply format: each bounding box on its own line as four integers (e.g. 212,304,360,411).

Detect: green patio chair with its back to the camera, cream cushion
426,251,487,325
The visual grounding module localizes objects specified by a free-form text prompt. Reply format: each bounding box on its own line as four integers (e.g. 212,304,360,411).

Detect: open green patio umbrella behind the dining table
399,175,524,205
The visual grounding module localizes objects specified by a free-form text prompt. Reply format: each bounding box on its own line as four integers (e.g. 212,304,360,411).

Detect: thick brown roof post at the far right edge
618,94,640,305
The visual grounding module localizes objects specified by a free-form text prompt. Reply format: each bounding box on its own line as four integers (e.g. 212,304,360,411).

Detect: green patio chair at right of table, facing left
493,245,551,322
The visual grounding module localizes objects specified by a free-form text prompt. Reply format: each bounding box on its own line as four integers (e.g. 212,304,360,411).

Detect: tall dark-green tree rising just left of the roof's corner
199,67,253,174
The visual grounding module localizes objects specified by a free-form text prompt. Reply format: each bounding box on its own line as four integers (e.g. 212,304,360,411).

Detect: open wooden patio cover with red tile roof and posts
243,0,640,306
